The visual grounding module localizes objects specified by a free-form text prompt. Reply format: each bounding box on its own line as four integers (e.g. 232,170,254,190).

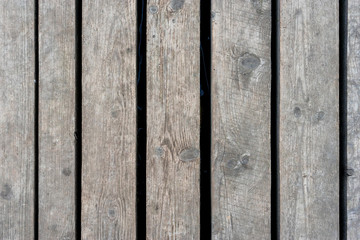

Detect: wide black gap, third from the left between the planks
136,0,147,240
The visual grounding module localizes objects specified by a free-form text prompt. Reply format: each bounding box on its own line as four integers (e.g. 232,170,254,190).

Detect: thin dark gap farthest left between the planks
34,0,39,240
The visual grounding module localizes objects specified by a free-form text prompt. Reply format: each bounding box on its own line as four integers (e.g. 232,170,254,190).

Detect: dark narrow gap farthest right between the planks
339,0,348,240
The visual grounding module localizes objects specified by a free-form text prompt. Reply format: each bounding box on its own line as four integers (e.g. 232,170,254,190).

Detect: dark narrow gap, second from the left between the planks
74,0,82,239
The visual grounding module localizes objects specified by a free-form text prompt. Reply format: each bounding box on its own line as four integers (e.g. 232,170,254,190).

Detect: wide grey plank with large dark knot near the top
211,0,271,239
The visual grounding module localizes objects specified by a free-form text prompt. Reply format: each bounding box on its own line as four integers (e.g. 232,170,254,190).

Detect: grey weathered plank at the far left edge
0,0,35,240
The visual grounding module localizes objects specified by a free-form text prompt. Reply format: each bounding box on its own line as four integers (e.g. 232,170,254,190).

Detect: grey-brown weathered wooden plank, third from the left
81,0,136,239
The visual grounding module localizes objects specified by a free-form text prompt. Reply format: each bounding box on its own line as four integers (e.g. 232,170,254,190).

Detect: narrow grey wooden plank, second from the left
39,0,75,239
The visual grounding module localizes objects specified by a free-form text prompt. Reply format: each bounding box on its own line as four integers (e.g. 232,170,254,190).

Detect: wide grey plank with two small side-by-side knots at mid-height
279,0,339,239
